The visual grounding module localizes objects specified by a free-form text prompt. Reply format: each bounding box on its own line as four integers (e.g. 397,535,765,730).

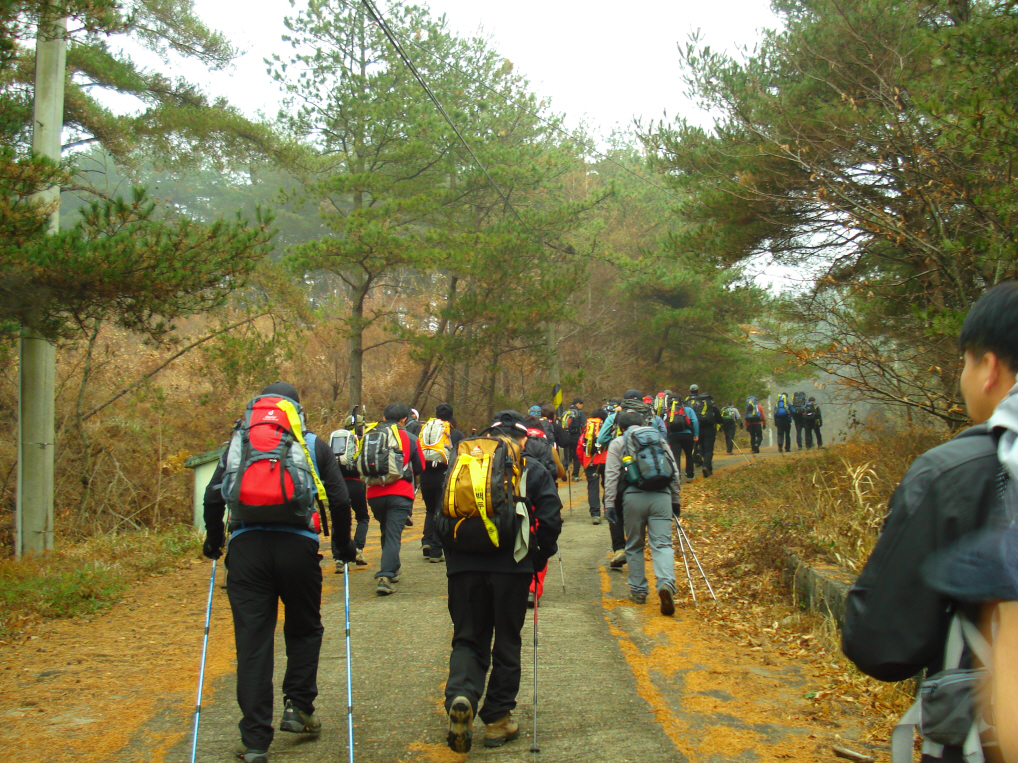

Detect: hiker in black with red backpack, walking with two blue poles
202,382,357,763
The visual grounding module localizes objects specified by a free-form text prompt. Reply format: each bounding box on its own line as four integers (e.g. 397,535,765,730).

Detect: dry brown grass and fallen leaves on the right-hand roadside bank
677,429,946,743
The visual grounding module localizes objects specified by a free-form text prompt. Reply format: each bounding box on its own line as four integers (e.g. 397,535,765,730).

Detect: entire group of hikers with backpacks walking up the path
196,284,1018,763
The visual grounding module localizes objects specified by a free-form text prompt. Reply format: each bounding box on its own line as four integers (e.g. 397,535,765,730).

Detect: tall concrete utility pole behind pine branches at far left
14,15,67,559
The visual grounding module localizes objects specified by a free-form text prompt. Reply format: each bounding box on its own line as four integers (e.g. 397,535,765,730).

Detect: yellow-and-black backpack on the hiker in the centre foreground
435,435,526,553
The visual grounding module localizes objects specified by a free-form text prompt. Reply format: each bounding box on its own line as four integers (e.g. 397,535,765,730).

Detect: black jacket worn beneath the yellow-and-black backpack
445,458,562,575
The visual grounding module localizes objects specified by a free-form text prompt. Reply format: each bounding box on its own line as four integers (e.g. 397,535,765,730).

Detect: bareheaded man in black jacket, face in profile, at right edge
842,282,1018,763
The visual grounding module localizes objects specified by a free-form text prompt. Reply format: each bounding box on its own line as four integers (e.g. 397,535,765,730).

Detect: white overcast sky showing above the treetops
187,0,777,134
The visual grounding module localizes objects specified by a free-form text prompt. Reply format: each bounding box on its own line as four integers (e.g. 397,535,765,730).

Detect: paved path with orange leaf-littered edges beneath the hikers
0,449,890,763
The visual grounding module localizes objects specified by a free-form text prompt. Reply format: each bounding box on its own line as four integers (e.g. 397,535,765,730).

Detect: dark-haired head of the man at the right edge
958,281,1018,424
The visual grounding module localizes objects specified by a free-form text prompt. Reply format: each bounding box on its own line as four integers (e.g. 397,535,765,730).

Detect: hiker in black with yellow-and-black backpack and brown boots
442,411,562,753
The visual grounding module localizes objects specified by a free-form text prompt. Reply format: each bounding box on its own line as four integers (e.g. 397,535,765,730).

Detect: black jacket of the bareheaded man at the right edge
842,425,1001,681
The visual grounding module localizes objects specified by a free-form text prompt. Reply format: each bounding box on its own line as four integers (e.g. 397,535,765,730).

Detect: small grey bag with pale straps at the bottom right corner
891,611,996,763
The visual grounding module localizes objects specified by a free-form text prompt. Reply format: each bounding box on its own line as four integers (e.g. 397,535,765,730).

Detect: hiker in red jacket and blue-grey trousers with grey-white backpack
357,403,425,596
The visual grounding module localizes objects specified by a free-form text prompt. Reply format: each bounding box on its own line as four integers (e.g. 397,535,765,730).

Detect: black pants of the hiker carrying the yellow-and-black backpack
445,572,533,723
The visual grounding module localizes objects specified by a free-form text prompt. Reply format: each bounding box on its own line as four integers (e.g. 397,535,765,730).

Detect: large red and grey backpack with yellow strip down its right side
222,395,328,530
